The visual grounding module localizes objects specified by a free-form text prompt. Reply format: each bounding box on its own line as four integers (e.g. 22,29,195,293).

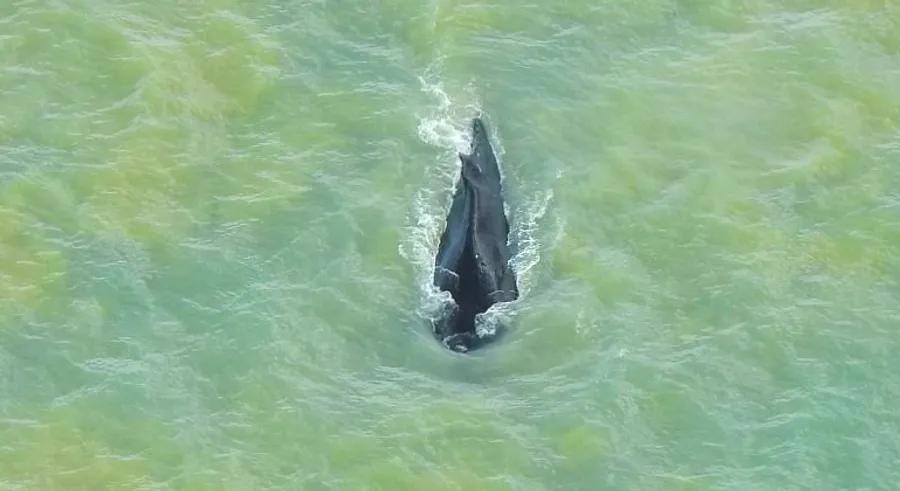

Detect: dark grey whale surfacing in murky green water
434,118,519,352
